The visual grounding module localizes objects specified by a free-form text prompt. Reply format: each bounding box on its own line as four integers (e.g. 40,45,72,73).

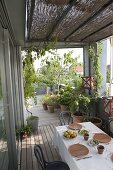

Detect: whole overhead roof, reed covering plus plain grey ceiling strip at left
2,0,113,47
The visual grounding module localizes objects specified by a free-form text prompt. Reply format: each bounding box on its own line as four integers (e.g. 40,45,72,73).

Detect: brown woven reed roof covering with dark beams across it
27,0,113,43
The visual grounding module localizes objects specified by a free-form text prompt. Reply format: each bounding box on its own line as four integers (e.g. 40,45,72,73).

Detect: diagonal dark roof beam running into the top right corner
64,0,113,41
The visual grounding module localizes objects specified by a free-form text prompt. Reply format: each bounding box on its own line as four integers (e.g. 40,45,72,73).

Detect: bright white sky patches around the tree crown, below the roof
34,48,83,70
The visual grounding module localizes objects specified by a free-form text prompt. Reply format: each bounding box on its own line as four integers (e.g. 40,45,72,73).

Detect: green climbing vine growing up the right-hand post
89,43,102,91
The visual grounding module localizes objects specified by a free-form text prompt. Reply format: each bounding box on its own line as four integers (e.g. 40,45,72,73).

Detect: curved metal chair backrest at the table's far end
59,111,73,126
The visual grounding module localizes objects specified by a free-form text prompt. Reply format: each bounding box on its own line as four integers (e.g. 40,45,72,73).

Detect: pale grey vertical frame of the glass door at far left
1,25,18,170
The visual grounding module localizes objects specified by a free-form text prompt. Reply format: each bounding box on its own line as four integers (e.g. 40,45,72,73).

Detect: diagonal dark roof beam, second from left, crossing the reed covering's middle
46,0,78,41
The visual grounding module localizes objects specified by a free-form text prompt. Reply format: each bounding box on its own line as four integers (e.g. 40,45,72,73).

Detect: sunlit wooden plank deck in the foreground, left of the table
19,123,61,170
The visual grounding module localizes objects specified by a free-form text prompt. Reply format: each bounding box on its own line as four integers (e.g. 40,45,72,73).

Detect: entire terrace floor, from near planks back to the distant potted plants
19,95,61,170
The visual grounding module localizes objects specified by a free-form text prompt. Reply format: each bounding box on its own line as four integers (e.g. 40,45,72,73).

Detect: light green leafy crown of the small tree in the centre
37,50,80,91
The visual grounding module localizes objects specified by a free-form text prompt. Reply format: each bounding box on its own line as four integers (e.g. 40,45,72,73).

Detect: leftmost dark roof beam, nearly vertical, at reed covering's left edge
27,0,35,40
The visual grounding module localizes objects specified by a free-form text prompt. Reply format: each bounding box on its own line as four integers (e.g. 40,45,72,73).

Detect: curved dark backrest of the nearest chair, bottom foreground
34,145,46,170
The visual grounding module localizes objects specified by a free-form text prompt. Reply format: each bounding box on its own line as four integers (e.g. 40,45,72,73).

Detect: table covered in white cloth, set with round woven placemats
53,122,113,170
